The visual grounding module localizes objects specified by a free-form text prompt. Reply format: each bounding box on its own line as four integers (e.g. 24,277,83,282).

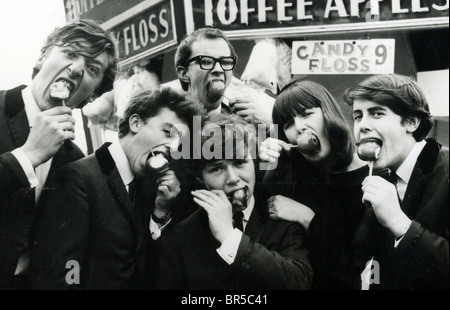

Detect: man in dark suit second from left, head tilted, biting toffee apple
31,88,204,290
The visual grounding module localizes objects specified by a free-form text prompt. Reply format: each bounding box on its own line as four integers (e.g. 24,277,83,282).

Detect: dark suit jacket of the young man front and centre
154,190,312,290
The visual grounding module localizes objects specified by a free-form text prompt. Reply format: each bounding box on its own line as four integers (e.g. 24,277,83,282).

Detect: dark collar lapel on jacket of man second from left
95,143,136,230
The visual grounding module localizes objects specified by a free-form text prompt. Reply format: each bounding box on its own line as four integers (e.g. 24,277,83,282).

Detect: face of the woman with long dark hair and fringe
283,108,331,166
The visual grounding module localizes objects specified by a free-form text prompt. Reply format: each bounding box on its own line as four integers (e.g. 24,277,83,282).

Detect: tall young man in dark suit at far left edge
0,20,118,289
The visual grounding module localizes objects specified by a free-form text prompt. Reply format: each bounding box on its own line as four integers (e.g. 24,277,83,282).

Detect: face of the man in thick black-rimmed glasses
177,39,233,111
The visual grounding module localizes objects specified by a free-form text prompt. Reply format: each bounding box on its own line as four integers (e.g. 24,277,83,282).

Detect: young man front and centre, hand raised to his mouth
154,114,312,290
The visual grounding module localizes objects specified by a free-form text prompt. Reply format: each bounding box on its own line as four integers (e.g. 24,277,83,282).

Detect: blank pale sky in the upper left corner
0,0,65,89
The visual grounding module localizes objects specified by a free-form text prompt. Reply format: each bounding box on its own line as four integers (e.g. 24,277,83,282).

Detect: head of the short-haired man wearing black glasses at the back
175,28,237,114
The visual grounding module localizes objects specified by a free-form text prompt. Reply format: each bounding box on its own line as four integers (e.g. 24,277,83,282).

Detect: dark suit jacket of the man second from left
31,143,156,289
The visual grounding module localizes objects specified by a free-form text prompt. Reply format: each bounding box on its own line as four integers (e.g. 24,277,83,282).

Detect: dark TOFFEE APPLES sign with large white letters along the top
184,0,450,38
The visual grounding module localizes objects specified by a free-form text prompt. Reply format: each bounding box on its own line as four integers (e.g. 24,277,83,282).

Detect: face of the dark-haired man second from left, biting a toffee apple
125,108,187,175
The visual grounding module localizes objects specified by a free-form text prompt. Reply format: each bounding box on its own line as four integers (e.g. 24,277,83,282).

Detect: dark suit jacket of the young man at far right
370,139,449,290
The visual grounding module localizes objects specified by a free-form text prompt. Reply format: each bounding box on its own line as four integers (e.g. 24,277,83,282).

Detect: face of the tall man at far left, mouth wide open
31,44,109,111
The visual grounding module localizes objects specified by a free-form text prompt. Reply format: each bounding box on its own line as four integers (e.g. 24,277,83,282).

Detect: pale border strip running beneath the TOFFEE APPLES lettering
225,17,449,39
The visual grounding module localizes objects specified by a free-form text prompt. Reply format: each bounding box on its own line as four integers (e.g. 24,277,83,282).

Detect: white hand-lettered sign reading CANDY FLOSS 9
292,39,395,74
